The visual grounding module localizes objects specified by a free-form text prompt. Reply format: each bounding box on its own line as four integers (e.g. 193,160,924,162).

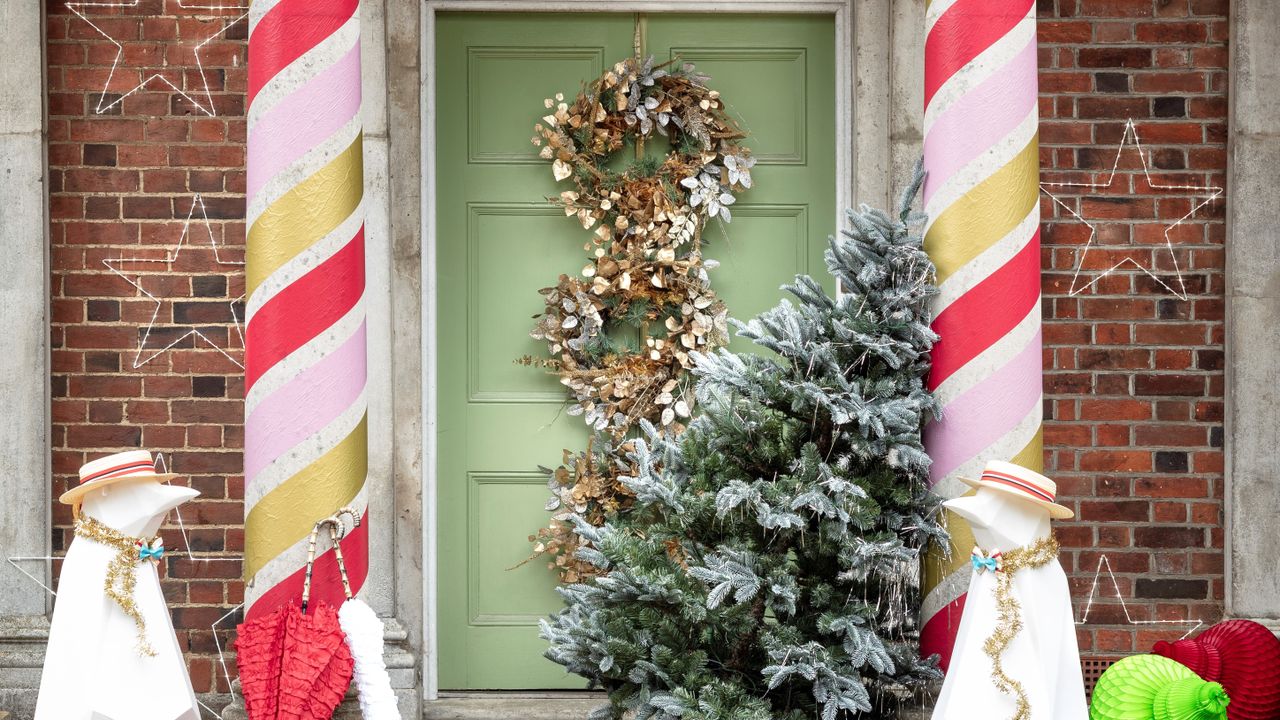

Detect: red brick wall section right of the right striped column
1038,0,1228,653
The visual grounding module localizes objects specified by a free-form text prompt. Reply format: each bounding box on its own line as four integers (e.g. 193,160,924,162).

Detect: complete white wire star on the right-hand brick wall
1041,118,1222,300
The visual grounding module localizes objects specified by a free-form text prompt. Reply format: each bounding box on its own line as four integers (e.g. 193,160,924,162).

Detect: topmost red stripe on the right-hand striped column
926,0,1034,108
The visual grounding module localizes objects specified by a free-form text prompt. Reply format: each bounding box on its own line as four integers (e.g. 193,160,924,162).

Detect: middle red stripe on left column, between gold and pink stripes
244,225,365,391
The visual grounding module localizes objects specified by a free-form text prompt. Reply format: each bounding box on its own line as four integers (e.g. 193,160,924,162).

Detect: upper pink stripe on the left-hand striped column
244,41,360,197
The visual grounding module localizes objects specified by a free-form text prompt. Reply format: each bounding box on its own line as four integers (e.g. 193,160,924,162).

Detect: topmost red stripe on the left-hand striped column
248,0,360,105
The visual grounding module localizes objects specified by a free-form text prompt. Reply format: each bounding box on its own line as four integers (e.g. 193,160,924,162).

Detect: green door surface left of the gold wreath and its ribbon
435,13,634,689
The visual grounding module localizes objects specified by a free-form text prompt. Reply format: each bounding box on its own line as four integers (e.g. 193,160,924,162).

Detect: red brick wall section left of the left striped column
47,0,247,692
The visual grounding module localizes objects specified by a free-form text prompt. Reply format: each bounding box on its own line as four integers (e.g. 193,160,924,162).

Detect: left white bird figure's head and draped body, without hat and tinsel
36,480,200,720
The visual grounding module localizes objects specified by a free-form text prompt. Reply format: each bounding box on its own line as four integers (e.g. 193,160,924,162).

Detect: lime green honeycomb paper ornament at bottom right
1089,655,1230,720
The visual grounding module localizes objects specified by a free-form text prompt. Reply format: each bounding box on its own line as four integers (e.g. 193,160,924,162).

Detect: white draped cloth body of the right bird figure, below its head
933,538,1089,720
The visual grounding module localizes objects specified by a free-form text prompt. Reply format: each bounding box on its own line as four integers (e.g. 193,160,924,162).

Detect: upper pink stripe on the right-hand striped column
923,38,1037,205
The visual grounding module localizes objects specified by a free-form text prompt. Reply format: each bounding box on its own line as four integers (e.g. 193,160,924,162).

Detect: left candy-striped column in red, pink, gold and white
244,0,369,618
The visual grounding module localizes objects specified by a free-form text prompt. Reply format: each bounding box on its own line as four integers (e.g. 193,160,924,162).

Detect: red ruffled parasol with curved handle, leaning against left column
236,512,353,720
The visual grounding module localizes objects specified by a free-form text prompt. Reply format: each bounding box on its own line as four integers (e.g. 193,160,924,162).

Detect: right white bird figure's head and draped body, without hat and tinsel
933,487,1088,720
